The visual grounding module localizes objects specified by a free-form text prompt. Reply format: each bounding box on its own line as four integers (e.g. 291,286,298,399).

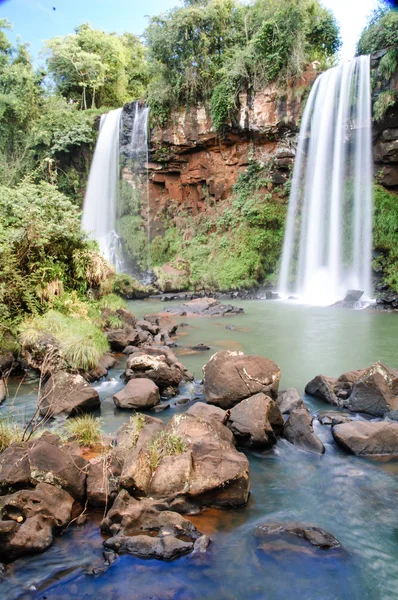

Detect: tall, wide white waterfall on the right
279,56,372,304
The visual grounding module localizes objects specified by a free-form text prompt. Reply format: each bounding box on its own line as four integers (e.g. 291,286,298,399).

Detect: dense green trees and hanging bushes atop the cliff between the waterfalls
145,0,340,129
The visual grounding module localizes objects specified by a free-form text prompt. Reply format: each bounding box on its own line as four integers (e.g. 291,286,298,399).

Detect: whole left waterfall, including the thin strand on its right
82,102,150,281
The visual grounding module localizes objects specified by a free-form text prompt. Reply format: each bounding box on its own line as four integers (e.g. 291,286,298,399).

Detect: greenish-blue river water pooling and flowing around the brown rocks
0,302,398,600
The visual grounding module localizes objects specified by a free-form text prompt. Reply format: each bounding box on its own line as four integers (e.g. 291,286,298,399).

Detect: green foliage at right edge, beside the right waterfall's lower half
373,185,398,292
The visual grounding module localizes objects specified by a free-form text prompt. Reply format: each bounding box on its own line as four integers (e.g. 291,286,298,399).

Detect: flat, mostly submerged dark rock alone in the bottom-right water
254,522,340,550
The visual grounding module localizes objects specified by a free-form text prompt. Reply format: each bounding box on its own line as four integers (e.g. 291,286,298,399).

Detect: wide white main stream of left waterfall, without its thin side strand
82,108,122,271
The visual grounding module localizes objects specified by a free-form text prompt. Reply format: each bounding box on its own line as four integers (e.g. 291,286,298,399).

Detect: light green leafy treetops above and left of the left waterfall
45,23,148,109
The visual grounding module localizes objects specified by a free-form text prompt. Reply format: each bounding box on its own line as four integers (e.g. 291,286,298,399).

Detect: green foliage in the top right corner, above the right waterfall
357,2,398,54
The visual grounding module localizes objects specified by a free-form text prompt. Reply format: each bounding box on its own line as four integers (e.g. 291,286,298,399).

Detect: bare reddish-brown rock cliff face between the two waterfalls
149,68,317,223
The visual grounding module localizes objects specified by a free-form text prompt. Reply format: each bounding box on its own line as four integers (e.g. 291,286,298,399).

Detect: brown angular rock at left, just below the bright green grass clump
39,371,101,417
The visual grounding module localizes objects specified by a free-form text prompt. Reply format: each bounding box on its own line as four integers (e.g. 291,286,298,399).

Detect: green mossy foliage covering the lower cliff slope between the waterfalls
151,161,287,290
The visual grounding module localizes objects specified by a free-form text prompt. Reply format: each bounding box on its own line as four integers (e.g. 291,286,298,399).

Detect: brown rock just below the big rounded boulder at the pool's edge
229,393,283,448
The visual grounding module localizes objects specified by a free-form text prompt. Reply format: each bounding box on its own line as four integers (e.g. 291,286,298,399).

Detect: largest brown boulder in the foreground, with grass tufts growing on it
120,413,250,512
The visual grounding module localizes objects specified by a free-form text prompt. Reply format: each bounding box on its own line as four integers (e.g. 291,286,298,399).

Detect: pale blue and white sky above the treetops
0,0,377,59
